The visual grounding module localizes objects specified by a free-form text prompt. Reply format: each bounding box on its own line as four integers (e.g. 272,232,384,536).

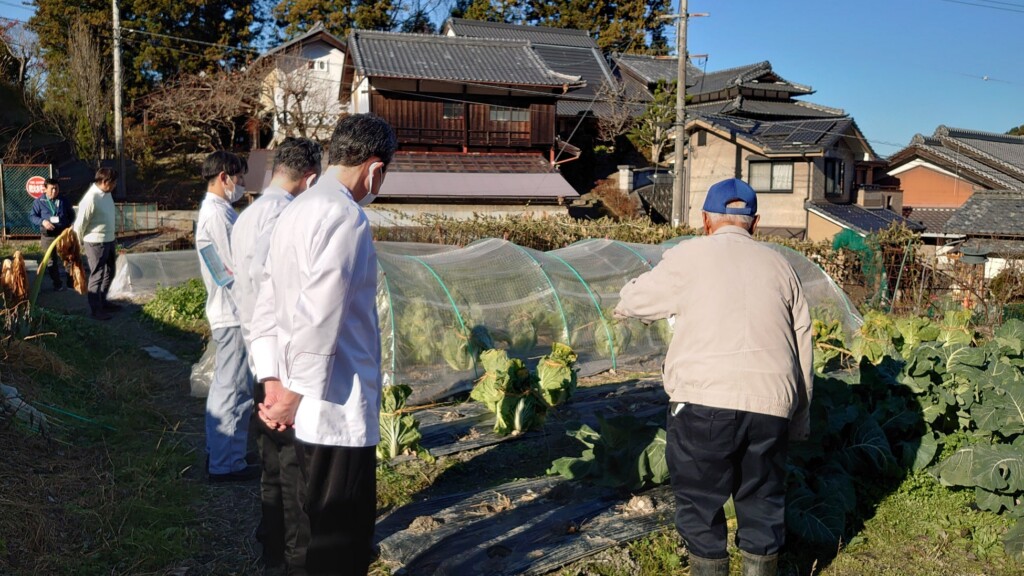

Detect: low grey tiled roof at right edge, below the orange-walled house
945,190,1024,238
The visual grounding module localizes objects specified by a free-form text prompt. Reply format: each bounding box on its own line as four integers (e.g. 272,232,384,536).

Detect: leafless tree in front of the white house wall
256,48,343,140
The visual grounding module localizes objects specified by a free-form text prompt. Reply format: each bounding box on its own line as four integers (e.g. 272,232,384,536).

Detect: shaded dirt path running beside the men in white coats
30,278,263,576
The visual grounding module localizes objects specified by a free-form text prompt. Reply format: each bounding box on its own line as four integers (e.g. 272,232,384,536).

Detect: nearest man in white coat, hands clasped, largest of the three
252,114,397,575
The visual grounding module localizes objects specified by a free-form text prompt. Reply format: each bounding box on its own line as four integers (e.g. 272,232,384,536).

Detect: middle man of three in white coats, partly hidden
231,138,324,576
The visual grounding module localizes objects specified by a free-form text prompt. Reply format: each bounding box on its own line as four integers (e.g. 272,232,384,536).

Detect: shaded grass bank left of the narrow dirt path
0,311,201,575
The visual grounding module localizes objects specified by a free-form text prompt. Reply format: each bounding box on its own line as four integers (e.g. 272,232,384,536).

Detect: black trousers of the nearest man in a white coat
297,441,377,576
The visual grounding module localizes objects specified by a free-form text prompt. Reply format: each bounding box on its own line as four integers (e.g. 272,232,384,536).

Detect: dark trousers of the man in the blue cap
666,404,790,559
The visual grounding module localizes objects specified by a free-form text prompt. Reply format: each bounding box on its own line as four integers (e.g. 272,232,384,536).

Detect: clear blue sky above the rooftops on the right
672,0,1024,156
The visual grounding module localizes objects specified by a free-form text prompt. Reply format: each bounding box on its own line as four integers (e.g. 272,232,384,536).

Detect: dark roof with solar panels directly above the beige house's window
698,115,860,154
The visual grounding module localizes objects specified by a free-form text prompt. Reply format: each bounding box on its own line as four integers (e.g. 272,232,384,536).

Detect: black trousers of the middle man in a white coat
253,383,309,576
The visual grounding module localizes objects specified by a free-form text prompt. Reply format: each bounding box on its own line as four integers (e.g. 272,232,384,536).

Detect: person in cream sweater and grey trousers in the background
74,168,121,320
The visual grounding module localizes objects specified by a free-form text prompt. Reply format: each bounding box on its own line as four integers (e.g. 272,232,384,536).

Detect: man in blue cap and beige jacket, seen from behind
615,178,813,576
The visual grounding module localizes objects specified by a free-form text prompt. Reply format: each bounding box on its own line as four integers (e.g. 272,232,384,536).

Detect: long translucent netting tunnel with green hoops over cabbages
377,238,860,403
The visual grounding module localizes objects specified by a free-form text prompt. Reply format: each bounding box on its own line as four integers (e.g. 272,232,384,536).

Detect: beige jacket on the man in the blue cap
615,227,813,440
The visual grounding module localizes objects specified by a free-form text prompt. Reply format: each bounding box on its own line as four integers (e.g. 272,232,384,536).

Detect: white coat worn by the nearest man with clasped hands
251,173,381,448
